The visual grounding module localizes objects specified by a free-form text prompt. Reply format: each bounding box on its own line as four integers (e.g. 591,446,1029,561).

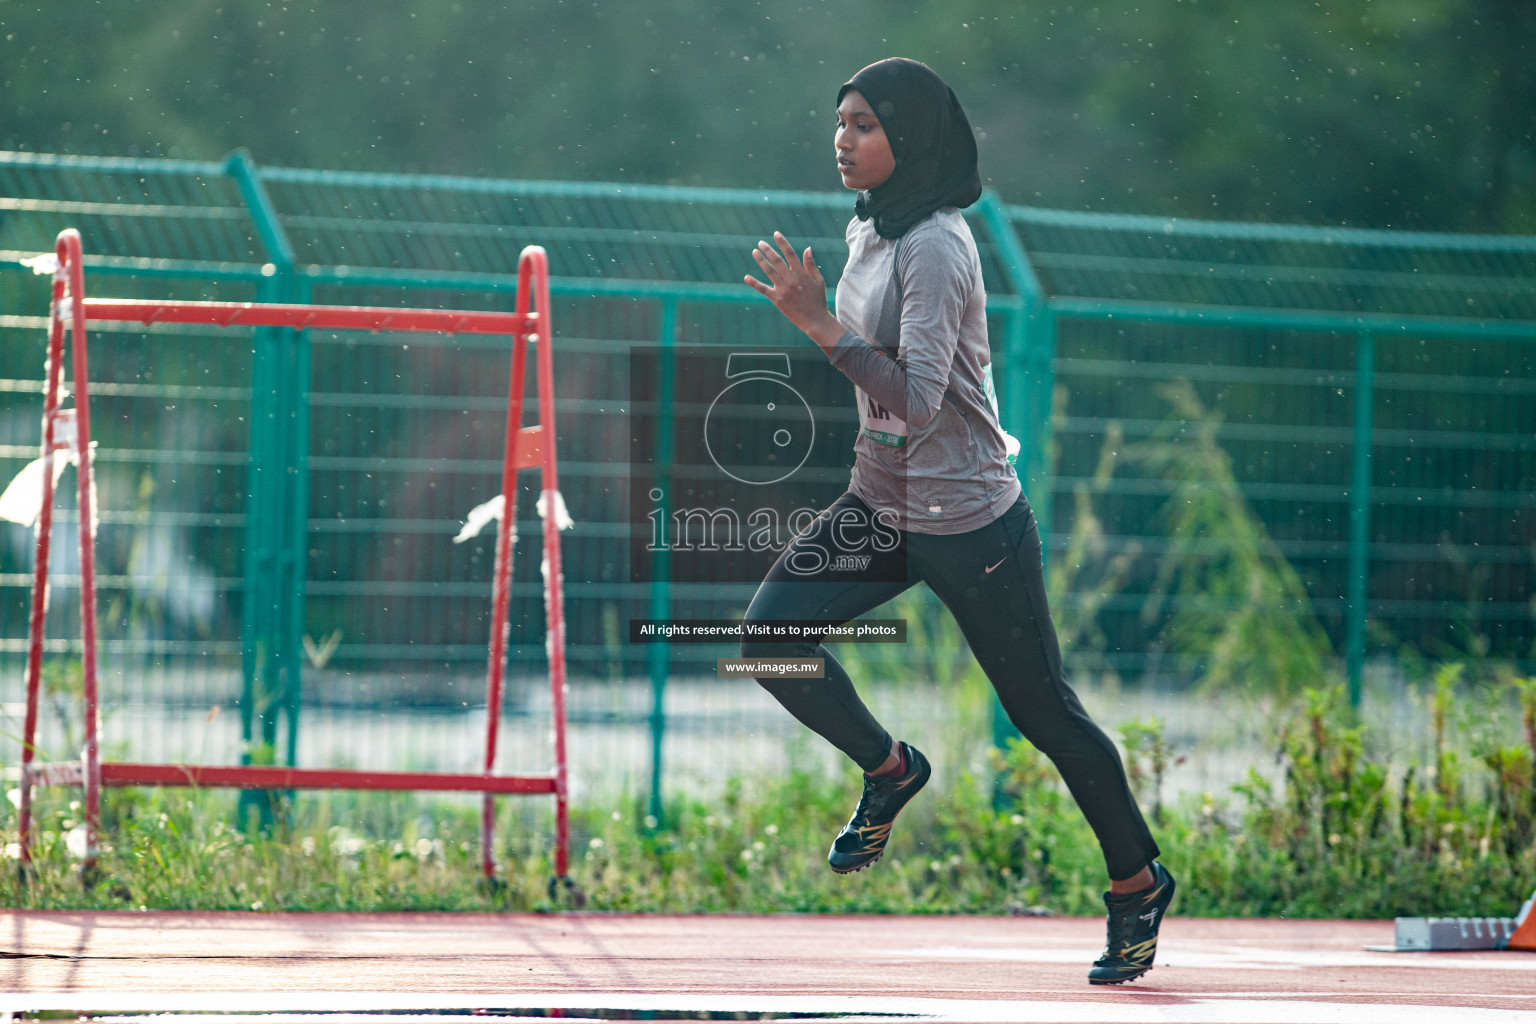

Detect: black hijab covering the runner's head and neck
837,57,982,238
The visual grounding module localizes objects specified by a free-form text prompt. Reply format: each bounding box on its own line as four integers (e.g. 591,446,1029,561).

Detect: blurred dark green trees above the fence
0,0,1536,233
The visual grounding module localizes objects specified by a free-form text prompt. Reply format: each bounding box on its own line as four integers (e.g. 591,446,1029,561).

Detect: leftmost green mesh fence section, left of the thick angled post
0,155,266,776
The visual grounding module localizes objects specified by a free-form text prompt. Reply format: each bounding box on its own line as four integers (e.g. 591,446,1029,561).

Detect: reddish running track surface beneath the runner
0,912,1536,1024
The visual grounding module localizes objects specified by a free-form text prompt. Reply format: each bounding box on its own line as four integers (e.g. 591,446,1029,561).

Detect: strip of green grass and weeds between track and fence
0,668,1536,918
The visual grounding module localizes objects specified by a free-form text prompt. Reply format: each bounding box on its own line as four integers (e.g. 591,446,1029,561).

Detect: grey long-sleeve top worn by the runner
831,207,1021,534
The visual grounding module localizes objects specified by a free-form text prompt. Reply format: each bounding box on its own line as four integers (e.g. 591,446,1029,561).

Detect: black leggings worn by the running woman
742,494,1158,880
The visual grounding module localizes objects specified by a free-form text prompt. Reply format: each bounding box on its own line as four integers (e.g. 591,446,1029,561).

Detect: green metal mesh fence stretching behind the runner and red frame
0,154,1536,798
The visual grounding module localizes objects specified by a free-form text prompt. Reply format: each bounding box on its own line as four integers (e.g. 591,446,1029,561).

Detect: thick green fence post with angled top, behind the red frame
224,149,299,826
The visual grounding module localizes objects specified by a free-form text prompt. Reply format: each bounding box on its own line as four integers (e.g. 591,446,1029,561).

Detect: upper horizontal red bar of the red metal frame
84,299,535,335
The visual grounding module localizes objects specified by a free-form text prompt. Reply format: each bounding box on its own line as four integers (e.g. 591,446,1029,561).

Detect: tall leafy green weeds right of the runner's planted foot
1184,666,1536,917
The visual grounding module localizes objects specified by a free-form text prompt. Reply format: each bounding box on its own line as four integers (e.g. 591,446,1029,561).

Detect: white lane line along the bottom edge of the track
0,990,1531,1024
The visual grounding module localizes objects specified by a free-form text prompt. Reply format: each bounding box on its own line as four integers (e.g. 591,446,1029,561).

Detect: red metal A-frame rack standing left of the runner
18,229,579,895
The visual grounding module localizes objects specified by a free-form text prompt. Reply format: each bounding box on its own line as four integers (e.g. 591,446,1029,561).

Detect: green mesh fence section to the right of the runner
1009,207,1536,687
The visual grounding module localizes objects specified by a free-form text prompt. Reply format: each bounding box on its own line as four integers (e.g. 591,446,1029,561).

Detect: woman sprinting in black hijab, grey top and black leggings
742,57,1174,984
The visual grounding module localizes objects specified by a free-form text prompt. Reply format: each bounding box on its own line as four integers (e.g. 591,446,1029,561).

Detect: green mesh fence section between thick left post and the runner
242,170,1032,792
